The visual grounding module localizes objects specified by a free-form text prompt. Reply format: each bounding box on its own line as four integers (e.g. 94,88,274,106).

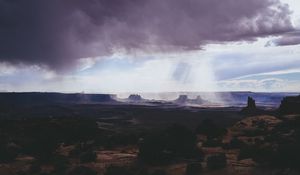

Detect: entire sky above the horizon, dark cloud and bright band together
0,0,300,93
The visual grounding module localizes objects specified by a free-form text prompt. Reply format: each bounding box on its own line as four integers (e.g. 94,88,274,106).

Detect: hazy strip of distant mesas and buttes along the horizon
0,92,299,107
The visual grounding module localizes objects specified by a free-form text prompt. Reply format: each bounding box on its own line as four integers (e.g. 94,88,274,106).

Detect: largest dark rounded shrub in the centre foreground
139,125,202,164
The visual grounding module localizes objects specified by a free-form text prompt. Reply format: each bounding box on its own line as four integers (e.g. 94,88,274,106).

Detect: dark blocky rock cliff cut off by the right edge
279,95,300,114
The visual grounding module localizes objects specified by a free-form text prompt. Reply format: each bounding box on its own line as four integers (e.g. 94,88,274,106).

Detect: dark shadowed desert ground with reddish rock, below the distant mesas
0,94,300,175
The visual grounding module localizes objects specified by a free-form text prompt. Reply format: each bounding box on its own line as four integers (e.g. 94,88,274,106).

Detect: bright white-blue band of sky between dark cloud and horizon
0,38,300,93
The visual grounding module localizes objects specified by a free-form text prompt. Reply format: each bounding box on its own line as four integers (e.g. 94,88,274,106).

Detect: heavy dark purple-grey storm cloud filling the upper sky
0,0,293,69
